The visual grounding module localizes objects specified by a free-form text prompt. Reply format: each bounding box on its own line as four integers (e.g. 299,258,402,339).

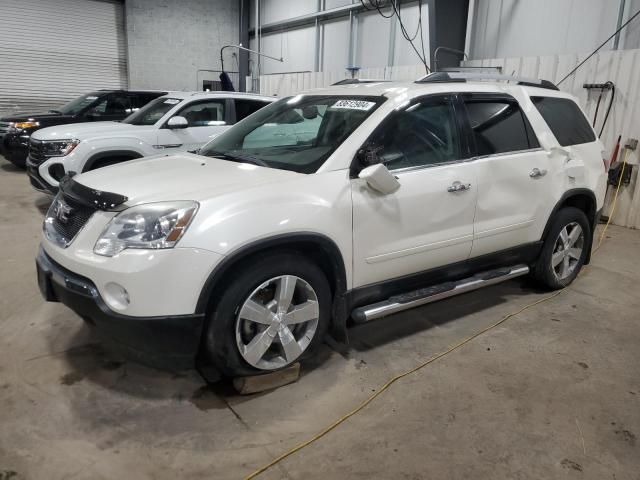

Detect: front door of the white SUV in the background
157,99,229,154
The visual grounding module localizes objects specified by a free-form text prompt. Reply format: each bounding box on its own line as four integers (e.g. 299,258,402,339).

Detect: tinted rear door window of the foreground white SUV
465,99,540,155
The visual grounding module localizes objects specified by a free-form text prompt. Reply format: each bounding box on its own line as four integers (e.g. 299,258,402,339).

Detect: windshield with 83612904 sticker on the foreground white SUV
200,95,385,173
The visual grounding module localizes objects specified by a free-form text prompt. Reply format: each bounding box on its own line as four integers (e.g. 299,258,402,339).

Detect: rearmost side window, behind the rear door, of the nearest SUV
531,97,596,147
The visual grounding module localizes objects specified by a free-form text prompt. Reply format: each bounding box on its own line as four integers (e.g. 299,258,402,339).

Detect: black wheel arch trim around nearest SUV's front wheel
195,232,348,342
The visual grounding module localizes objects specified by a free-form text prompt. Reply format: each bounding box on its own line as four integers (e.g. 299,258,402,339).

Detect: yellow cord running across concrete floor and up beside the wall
245,150,629,480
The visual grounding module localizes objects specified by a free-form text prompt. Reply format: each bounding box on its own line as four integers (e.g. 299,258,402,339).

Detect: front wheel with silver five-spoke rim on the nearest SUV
203,253,331,376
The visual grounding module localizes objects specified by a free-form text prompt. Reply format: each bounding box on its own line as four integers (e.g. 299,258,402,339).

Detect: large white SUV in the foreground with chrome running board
37,74,606,376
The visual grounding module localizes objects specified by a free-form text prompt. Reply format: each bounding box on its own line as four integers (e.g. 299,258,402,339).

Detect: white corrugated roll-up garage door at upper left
0,0,127,115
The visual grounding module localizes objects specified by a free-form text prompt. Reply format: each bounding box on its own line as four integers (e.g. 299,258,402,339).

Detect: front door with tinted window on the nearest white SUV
352,96,477,287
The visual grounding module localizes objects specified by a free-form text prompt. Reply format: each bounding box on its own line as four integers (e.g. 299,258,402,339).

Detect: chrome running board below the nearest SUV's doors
351,265,529,323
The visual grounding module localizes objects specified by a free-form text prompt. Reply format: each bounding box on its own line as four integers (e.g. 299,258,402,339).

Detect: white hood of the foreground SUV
73,153,306,206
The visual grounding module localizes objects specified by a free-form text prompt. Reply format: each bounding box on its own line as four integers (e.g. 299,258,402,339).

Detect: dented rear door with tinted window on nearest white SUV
462,93,558,257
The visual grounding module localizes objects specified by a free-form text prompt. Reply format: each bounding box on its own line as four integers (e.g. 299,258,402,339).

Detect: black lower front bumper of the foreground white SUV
36,248,204,369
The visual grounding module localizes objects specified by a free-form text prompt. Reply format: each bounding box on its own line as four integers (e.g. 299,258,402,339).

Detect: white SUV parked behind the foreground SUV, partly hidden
27,92,275,193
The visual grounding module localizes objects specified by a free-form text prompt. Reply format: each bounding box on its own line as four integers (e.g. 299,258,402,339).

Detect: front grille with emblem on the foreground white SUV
45,194,96,247
